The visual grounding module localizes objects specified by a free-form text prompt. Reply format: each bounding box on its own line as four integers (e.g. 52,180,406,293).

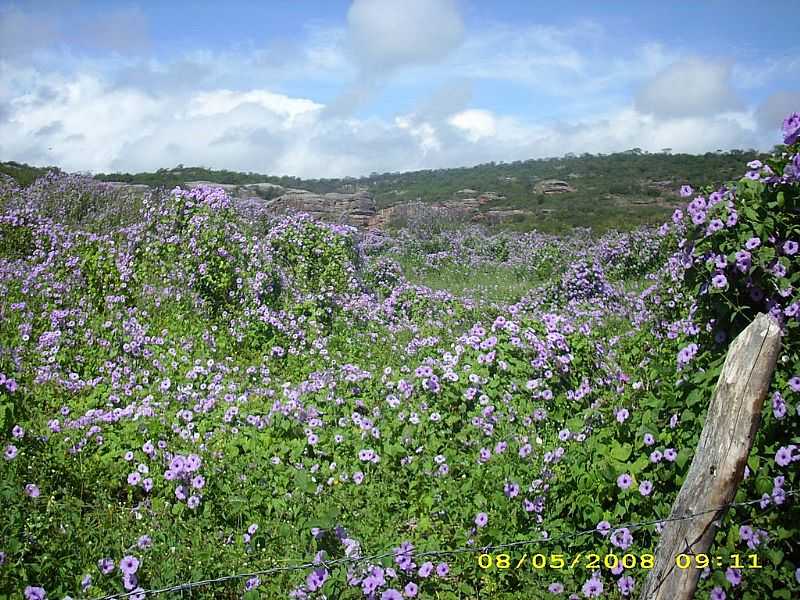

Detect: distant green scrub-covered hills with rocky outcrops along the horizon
0,148,766,232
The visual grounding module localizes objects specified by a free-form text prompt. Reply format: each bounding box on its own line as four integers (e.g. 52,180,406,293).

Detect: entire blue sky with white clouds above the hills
0,0,800,178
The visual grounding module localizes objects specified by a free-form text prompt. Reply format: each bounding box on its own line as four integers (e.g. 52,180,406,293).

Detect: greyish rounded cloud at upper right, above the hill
636,58,742,117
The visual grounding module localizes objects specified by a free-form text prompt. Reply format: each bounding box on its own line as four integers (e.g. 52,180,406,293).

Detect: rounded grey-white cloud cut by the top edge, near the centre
347,0,464,74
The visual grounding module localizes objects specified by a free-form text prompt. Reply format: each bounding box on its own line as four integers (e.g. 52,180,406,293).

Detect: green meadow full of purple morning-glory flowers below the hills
0,115,800,600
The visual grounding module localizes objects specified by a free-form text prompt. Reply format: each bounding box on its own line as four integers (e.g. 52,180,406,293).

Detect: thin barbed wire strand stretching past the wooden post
98,490,800,600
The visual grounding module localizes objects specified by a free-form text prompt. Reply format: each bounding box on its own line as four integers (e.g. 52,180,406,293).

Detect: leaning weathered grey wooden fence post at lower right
639,314,781,600
